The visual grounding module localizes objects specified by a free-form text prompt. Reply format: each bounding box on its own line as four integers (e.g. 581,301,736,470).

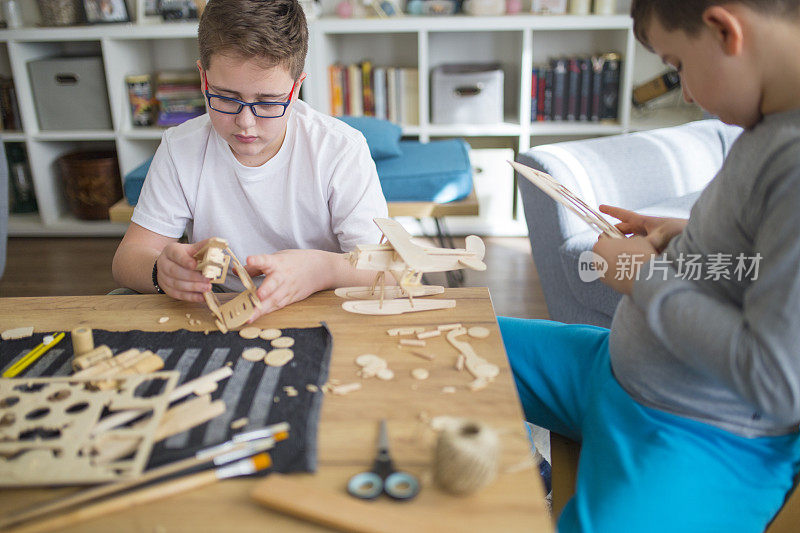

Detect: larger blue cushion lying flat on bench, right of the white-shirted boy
375,139,472,203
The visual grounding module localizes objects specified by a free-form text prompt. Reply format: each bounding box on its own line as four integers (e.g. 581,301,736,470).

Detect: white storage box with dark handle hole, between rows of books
431,63,503,124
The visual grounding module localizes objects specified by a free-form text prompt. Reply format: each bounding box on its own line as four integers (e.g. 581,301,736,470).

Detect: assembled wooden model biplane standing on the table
335,218,486,315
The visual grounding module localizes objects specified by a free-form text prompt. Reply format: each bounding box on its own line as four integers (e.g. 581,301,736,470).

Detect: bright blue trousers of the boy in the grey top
499,317,800,533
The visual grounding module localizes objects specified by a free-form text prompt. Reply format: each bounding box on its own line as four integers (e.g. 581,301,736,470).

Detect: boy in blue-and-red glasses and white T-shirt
113,0,387,319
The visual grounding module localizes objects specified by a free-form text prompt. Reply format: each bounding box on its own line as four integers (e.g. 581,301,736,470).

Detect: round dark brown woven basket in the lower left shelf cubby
58,151,122,220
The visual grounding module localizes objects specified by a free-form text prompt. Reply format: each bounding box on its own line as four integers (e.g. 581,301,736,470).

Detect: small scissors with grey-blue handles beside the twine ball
347,420,419,500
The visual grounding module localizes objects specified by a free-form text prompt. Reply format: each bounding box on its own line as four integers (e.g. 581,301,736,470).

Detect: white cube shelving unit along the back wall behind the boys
0,11,700,236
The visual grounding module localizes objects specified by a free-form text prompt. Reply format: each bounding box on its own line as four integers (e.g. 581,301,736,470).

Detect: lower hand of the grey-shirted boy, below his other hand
592,234,657,294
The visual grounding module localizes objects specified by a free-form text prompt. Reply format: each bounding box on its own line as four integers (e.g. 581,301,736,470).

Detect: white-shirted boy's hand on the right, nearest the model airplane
245,250,329,322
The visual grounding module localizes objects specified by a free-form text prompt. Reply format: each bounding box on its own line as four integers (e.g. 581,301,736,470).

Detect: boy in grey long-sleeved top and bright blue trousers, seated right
500,0,800,532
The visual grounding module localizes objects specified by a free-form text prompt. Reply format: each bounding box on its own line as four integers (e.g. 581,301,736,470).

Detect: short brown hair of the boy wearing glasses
197,0,308,80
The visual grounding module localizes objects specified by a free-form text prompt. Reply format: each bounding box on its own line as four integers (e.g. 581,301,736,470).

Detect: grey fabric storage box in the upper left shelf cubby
28,57,112,130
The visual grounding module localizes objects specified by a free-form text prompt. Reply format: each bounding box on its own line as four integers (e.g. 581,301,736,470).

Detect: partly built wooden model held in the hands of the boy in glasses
194,237,261,333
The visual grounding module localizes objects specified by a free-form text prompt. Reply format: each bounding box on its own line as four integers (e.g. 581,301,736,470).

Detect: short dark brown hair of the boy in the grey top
631,0,800,46
